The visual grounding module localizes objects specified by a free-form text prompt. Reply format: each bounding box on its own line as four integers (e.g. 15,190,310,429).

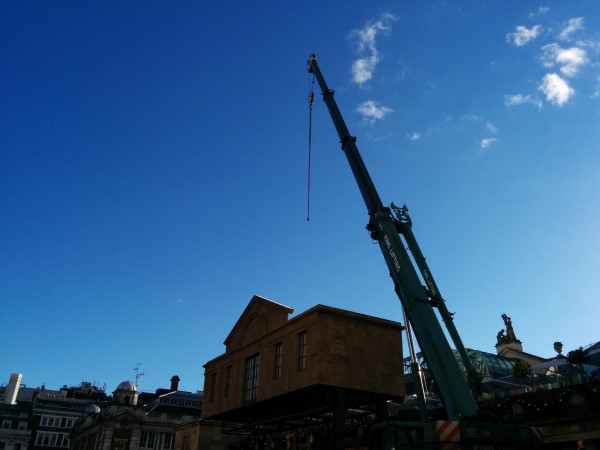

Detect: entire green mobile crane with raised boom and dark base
308,54,541,450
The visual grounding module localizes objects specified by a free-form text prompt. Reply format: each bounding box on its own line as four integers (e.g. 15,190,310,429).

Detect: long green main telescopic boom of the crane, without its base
308,55,478,420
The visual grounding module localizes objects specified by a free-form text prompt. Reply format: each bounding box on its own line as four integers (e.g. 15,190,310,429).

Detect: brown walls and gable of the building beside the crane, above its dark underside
202,296,404,418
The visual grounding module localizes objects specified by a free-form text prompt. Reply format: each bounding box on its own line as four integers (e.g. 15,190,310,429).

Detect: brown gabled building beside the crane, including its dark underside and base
202,296,404,448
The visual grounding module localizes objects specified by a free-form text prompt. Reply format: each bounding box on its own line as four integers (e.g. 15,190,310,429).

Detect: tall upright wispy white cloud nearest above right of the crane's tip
351,13,397,86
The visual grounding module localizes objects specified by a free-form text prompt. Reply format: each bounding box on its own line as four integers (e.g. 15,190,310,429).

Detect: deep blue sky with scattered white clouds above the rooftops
0,0,600,392
